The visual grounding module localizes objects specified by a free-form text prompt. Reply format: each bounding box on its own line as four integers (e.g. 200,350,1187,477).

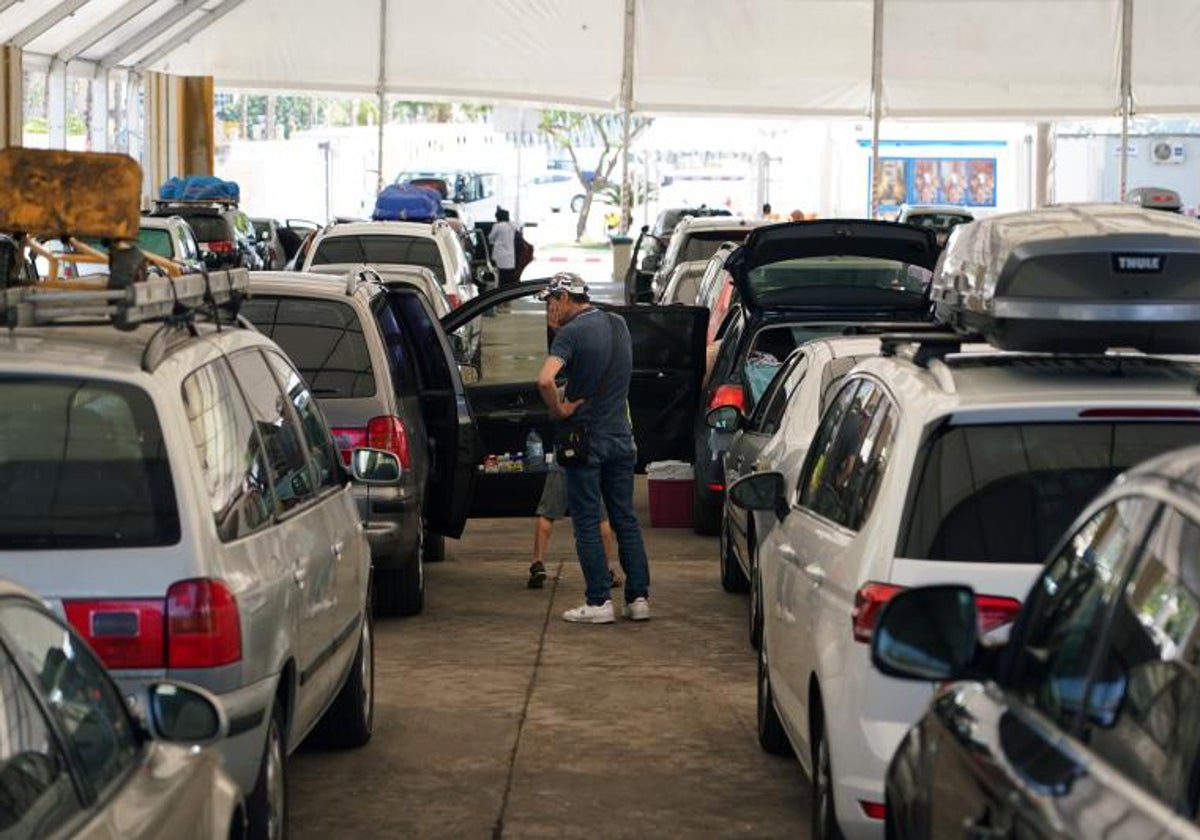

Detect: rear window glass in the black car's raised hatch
748,257,932,308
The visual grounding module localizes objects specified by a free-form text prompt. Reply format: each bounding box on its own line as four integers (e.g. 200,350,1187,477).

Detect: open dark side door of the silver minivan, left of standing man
386,283,480,538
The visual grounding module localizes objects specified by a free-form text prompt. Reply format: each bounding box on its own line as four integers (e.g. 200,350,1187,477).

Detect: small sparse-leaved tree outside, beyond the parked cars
540,110,653,241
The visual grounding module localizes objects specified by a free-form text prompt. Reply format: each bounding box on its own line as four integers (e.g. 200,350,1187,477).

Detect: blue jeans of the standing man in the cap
566,434,650,606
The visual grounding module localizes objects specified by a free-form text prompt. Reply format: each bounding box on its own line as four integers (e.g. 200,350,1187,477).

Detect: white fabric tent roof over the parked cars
9,0,1200,118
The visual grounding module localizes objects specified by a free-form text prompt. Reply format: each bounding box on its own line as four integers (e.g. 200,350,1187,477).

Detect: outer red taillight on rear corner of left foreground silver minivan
167,578,241,668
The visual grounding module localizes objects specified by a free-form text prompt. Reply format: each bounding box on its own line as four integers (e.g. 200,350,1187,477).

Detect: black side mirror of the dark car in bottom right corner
871,586,979,682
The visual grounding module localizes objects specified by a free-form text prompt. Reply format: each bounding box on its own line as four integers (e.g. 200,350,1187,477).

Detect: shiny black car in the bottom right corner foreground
871,448,1200,838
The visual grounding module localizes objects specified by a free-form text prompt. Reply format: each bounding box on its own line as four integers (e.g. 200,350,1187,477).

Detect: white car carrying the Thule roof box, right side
730,209,1200,838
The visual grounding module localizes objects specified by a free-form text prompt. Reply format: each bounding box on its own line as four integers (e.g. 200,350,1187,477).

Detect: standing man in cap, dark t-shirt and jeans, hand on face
538,272,650,624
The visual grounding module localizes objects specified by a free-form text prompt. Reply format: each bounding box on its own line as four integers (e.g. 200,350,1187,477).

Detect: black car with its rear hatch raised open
691,218,938,534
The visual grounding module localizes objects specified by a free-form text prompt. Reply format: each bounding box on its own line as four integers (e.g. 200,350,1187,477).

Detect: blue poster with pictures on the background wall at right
868,157,996,214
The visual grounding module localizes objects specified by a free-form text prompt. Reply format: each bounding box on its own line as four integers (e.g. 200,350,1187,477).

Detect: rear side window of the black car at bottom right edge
1087,511,1200,815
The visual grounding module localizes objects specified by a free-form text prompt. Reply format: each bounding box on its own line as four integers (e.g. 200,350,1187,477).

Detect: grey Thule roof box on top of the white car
930,204,1200,353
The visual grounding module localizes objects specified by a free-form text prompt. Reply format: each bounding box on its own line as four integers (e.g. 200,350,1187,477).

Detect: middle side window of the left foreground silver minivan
229,350,314,511
